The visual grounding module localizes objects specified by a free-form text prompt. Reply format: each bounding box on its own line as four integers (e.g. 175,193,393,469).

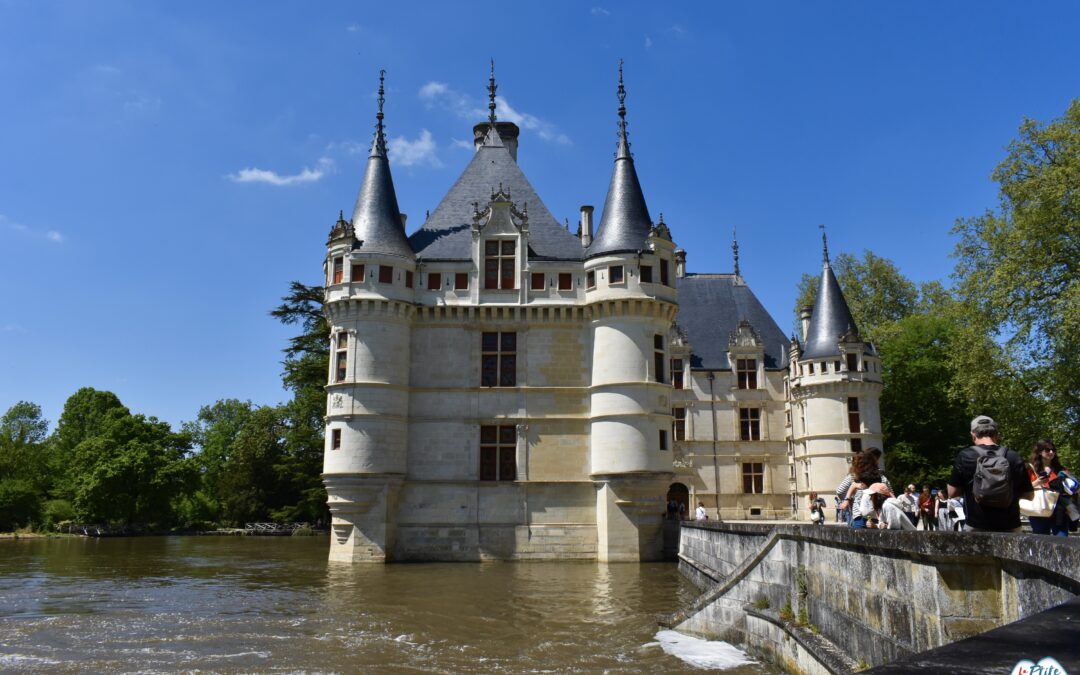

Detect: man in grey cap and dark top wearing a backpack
948,415,1034,532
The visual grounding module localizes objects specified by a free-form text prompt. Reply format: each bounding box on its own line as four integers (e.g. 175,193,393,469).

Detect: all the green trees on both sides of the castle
0,100,1080,531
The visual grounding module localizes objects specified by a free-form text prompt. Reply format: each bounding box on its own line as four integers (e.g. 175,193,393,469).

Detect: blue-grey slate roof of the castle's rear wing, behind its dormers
675,274,788,370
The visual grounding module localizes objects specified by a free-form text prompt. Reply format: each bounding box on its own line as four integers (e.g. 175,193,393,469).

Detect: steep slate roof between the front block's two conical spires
409,123,582,260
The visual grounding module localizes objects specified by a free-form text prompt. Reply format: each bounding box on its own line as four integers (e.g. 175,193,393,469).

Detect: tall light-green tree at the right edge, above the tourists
954,99,1080,461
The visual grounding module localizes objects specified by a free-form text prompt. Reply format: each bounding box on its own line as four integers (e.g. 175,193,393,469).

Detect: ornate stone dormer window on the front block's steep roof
472,185,529,291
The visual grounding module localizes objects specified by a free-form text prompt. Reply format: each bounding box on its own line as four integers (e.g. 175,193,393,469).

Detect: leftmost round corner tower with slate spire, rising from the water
323,71,416,563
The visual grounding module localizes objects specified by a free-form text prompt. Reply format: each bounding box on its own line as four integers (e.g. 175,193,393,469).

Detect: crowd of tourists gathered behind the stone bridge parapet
809,415,1080,537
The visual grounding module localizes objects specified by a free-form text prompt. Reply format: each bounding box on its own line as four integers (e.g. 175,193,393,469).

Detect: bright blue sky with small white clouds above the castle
0,0,1080,424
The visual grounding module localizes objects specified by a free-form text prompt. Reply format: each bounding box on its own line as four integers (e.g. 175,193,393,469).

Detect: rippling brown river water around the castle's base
0,537,775,673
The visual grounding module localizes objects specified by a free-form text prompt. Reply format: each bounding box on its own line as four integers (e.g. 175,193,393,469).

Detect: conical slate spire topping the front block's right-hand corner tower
586,60,652,258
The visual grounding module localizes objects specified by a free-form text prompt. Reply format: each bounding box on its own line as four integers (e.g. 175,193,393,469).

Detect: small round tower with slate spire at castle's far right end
788,227,882,510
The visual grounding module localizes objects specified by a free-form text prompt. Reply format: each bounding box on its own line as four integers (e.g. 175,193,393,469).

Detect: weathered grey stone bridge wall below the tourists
666,523,1080,674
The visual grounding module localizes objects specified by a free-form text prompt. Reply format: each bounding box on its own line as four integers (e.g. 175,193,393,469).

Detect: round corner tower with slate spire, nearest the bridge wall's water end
584,62,677,562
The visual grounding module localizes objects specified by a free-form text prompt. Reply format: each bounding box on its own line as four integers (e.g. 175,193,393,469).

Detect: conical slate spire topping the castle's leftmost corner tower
352,70,414,258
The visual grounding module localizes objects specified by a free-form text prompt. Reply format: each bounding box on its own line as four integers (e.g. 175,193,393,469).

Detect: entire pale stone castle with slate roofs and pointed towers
324,71,881,562
